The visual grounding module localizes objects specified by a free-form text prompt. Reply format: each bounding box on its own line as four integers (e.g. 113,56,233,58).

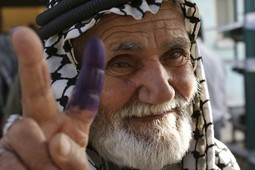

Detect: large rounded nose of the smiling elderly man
136,62,175,104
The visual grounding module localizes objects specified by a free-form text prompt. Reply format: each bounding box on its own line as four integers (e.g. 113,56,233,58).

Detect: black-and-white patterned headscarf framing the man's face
41,0,240,170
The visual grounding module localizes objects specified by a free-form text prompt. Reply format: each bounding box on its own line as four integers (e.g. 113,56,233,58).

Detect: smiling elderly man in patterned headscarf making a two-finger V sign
0,0,239,170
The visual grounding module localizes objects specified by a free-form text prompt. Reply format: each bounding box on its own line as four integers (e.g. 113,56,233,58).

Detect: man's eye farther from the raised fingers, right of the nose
161,48,189,67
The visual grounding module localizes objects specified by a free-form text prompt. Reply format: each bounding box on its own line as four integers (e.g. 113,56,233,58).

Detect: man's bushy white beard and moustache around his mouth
90,93,192,170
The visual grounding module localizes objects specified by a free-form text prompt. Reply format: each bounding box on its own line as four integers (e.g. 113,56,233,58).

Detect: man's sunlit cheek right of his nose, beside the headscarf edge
170,64,197,99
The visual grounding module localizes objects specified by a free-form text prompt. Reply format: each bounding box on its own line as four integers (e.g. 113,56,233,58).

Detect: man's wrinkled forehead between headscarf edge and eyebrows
76,1,185,40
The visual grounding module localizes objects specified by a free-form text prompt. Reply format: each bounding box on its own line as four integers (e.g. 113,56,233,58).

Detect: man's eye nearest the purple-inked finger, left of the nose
106,55,138,77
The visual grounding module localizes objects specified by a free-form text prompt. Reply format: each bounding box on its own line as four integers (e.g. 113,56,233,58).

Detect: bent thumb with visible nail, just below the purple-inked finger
49,133,89,170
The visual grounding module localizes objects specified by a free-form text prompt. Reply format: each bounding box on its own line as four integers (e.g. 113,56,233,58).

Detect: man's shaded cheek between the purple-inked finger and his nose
99,75,135,118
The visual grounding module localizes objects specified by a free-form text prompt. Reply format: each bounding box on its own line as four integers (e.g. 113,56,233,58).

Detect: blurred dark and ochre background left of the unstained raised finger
0,0,46,145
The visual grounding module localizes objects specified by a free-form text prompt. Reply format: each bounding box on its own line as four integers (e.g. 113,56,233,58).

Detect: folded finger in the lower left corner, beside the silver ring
2,119,58,170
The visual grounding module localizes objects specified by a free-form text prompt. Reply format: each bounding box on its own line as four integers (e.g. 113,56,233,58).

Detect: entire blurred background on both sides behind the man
0,0,255,169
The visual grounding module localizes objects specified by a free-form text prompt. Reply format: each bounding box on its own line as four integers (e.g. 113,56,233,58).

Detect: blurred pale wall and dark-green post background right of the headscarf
194,0,255,169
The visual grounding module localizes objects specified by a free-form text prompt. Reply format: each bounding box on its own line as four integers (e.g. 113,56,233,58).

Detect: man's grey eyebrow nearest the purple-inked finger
111,42,143,51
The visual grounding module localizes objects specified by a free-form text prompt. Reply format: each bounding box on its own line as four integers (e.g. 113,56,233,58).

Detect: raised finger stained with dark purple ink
67,38,105,111
